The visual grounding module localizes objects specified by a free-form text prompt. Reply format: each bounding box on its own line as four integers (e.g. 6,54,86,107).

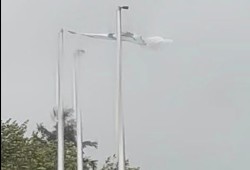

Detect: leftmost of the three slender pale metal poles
57,29,64,170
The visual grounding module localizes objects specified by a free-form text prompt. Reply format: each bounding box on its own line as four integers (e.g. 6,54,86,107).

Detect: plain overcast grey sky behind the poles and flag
1,0,250,170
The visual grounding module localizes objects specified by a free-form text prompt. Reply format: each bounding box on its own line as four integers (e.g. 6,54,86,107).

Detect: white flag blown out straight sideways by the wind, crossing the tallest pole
68,31,173,47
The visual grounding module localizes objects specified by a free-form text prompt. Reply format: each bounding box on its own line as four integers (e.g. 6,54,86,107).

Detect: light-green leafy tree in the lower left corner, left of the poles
1,119,56,170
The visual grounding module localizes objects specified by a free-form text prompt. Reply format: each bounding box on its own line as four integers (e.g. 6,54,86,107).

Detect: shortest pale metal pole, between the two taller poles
73,50,84,170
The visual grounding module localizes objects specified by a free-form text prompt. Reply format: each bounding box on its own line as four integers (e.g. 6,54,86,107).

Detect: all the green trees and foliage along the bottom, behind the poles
1,110,139,170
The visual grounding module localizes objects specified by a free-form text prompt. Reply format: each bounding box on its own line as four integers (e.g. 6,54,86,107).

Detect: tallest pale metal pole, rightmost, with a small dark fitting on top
116,6,128,170
